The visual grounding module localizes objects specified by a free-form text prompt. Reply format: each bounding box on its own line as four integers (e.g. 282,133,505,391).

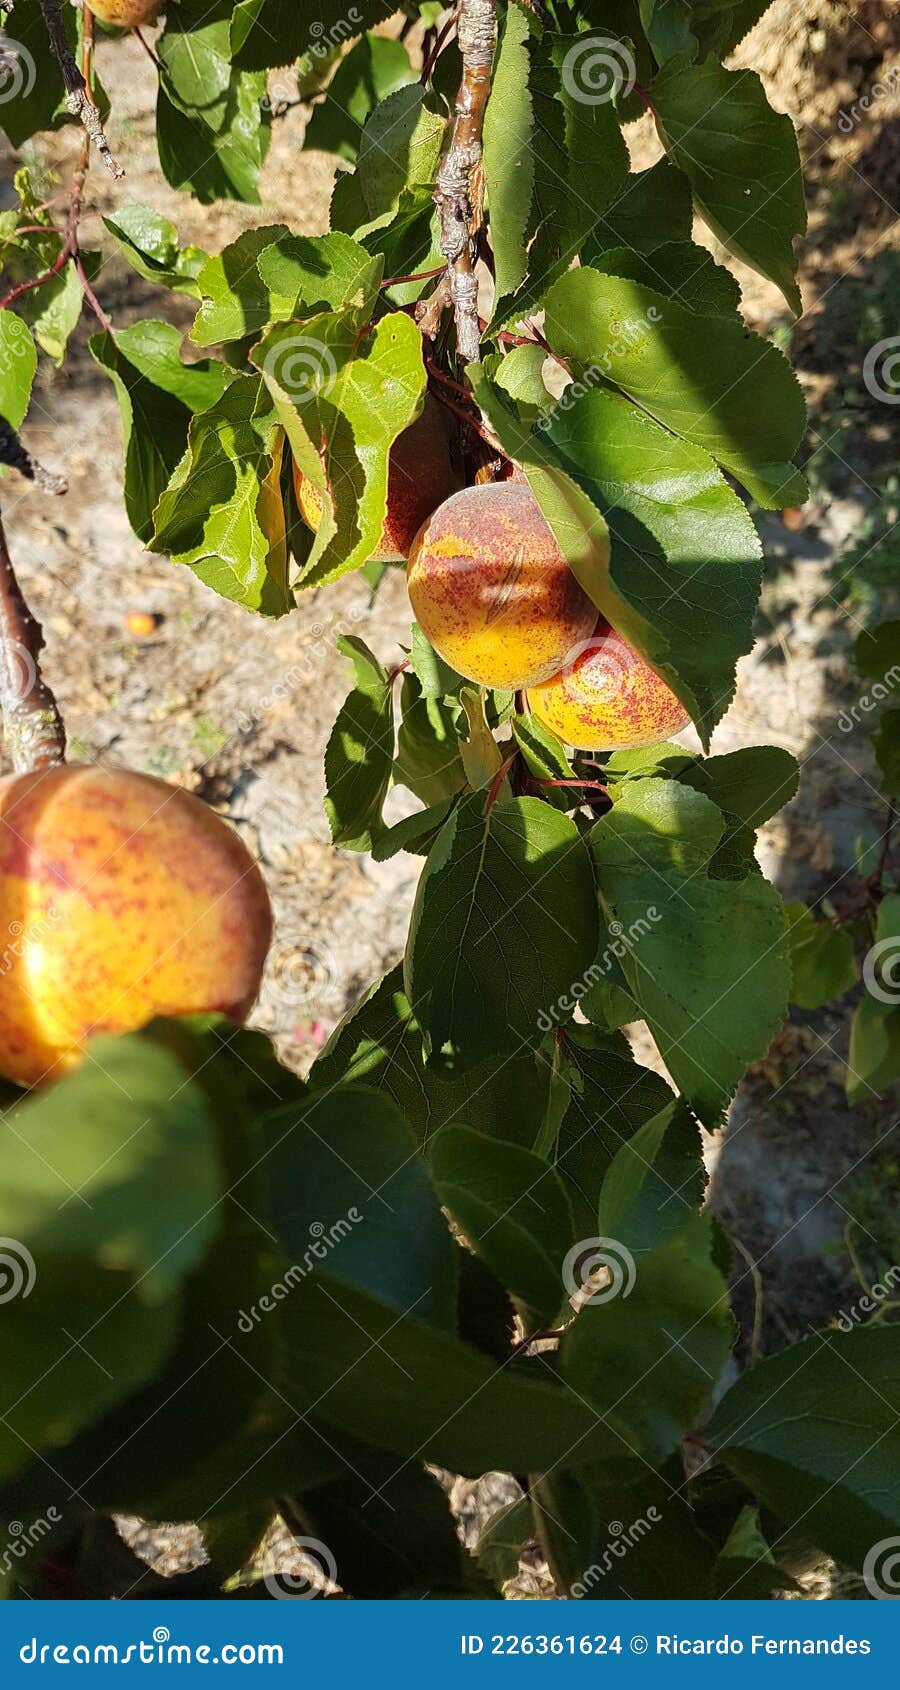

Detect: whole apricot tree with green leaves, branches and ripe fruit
0,0,900,1599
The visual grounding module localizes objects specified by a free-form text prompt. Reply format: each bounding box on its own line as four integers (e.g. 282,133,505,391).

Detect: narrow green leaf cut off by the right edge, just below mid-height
848,892,900,1104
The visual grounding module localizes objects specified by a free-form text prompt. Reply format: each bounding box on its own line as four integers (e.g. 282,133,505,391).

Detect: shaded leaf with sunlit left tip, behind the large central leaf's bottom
311,968,550,1149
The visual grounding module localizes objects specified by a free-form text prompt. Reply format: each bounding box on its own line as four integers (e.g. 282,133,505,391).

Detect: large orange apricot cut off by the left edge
0,764,272,1085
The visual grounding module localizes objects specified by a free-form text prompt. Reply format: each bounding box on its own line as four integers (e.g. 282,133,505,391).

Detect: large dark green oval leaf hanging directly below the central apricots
405,793,596,1068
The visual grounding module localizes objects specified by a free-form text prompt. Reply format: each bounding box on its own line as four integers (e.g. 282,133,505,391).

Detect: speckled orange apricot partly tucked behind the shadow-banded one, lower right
529,619,691,750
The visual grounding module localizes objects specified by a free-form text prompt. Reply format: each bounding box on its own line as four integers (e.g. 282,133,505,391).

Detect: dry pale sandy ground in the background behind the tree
0,0,900,1594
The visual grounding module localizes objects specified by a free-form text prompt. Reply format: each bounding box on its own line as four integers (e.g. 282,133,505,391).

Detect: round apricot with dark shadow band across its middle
407,480,596,688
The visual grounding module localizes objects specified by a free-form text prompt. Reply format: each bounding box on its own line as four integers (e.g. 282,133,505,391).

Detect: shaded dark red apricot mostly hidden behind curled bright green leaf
294,394,461,563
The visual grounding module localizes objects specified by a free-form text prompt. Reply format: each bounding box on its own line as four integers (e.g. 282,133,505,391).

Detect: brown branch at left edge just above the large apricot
0,517,66,774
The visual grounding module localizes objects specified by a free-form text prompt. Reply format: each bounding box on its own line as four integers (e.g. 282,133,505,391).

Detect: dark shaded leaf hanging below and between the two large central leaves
554,1020,672,1235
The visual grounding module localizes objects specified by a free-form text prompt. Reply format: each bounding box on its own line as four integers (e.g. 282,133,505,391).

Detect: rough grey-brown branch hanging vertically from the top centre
419,0,496,363
